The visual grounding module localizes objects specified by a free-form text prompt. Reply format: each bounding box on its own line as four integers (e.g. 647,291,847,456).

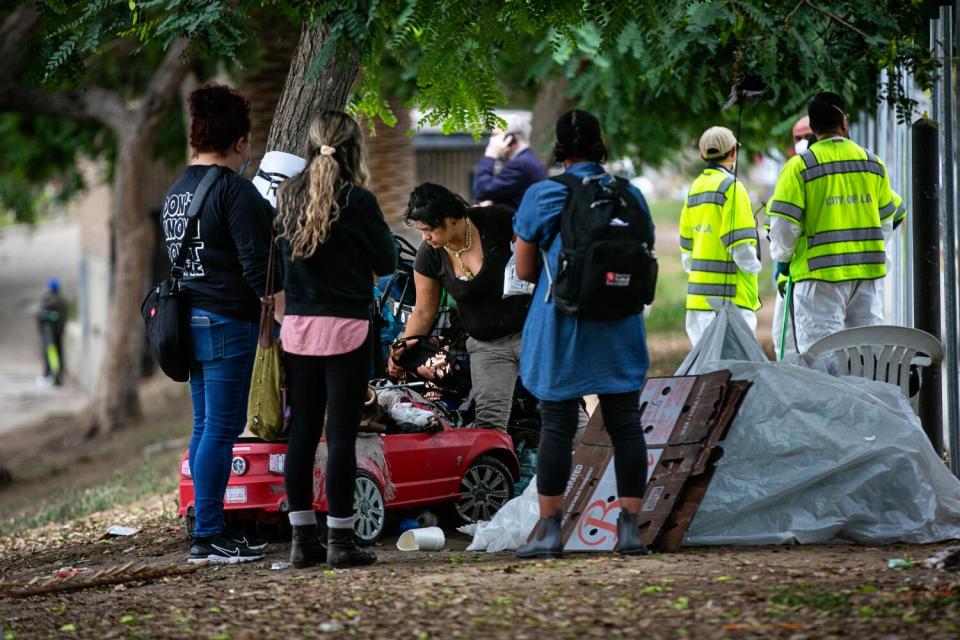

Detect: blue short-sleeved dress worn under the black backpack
513,162,653,401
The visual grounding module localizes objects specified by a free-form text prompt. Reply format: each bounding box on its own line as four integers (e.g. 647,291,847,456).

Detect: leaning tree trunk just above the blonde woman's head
267,25,360,156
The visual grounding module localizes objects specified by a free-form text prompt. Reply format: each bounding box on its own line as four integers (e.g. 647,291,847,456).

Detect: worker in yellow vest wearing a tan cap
680,127,762,345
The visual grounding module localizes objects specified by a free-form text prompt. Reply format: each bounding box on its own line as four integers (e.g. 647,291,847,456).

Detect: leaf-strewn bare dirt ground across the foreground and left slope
0,364,960,640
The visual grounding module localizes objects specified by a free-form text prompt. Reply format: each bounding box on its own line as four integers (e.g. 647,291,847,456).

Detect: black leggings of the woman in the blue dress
537,391,647,498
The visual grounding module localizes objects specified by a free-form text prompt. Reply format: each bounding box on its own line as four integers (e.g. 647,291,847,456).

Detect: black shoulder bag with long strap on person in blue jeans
140,165,223,382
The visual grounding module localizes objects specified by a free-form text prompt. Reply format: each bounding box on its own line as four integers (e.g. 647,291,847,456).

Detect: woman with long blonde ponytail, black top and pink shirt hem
277,111,397,567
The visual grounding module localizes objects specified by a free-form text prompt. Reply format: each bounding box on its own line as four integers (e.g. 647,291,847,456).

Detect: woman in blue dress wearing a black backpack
514,110,656,558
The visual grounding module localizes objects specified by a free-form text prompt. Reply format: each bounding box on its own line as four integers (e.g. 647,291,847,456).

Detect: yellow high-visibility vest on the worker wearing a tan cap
680,166,760,311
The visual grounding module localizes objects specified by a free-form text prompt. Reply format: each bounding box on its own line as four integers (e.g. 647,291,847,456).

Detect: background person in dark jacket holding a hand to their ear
471,115,547,211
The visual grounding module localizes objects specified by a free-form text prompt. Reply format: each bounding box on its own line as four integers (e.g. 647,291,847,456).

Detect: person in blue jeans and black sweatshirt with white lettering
162,84,271,564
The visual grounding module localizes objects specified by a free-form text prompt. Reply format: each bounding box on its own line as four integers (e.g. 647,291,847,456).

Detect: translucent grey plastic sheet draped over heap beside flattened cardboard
685,361,960,545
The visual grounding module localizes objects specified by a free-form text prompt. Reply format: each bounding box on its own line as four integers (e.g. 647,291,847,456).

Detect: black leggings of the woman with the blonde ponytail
283,340,370,518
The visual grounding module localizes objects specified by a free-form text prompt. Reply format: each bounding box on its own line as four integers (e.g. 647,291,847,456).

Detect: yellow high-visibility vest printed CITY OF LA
767,137,892,282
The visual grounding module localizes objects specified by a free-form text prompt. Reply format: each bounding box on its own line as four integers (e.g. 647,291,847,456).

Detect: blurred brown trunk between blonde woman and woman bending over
363,97,417,233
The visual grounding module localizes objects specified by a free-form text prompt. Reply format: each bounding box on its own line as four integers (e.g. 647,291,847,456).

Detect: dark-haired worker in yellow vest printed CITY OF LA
767,92,897,353
